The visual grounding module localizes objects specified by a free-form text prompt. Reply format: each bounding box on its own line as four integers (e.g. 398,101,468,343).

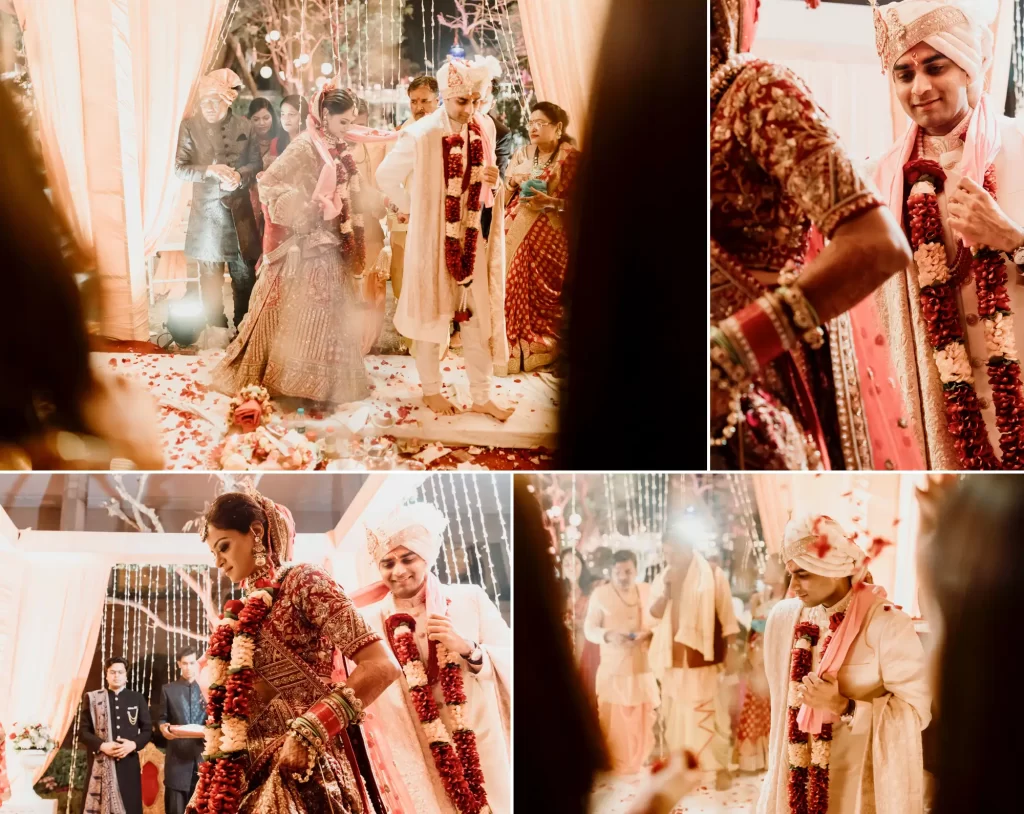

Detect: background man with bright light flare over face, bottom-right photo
650,527,739,786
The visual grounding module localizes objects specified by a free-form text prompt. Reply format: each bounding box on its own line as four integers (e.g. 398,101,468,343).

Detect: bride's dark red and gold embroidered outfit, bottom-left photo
188,564,381,814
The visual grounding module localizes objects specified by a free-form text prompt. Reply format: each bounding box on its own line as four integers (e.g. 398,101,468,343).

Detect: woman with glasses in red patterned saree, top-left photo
505,101,580,374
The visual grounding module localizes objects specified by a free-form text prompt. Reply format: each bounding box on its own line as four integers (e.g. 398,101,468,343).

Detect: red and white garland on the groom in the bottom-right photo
786,611,846,814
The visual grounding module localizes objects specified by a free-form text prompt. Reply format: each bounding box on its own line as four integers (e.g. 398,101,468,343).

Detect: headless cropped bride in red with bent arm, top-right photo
709,0,923,469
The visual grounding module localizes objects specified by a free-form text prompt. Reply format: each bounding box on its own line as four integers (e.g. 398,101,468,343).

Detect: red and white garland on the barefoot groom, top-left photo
441,121,483,323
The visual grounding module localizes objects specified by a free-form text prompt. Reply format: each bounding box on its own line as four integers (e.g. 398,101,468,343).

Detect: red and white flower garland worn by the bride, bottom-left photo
196,577,281,814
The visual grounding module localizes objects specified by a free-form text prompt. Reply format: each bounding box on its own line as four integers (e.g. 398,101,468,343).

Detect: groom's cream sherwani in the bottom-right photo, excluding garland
757,592,932,814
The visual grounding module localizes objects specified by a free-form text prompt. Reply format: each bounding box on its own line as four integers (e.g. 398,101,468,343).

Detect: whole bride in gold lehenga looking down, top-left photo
213,83,395,404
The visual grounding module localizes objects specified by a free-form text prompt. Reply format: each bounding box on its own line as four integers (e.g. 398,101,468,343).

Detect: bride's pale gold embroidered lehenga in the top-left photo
213,130,370,403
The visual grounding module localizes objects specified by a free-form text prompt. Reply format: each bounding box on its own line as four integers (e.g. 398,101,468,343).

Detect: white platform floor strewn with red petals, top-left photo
92,350,558,469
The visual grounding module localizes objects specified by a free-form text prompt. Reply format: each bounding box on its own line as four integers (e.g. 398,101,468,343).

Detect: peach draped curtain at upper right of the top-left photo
519,0,606,144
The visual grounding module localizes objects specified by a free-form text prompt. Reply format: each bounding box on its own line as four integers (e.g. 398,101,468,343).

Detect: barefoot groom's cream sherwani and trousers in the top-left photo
377,105,508,404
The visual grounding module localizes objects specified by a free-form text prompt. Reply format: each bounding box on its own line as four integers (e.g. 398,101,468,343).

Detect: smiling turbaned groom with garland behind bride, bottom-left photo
357,504,512,814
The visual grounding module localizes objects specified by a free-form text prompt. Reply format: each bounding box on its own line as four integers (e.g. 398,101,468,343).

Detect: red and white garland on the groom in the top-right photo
903,159,1024,469
